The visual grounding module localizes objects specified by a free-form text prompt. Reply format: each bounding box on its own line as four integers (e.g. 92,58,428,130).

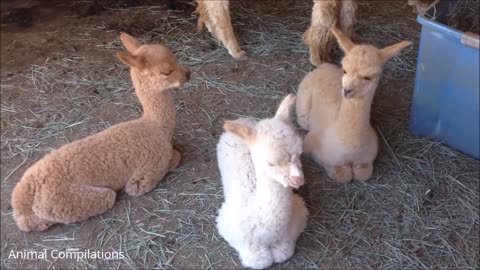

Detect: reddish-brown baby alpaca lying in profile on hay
12,33,190,231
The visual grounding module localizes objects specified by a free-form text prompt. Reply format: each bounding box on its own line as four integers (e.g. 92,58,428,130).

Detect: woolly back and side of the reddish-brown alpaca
22,118,172,191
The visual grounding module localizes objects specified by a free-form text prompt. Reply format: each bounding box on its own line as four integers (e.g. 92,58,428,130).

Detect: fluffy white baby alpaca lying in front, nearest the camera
217,95,308,269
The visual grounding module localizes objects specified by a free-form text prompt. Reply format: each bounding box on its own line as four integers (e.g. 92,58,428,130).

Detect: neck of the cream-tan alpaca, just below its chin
336,94,373,130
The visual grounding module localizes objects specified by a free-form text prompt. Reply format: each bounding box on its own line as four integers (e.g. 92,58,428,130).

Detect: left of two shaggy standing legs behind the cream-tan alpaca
303,0,341,66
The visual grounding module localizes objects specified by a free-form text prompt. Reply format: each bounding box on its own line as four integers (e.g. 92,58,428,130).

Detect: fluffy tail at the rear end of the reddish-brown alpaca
12,178,40,232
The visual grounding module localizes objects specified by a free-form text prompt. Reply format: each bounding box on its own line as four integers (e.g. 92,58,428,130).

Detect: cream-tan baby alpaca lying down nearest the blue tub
297,28,411,182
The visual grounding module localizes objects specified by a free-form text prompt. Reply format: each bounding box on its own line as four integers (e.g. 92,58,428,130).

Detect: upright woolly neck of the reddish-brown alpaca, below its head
130,69,175,125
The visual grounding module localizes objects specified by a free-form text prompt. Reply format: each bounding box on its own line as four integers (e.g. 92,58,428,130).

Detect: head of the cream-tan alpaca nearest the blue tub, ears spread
331,28,411,98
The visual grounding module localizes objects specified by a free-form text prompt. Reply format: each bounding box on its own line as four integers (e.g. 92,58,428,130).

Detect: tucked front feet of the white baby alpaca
238,245,273,269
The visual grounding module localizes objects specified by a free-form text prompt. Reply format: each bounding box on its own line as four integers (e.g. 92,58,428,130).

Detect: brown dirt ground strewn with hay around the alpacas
1,0,480,269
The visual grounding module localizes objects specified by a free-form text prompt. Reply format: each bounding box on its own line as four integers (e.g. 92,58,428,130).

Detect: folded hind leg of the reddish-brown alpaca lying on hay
33,184,117,223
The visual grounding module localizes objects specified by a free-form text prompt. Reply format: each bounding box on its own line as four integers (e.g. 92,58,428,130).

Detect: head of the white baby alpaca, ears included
223,94,305,188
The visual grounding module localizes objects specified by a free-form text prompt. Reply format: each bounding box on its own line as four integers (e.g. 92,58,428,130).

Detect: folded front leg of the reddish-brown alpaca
125,168,167,197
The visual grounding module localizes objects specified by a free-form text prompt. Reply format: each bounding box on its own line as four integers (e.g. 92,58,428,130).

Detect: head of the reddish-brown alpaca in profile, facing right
117,33,190,90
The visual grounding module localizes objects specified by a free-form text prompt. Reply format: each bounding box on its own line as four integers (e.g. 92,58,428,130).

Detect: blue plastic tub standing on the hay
410,1,480,159
